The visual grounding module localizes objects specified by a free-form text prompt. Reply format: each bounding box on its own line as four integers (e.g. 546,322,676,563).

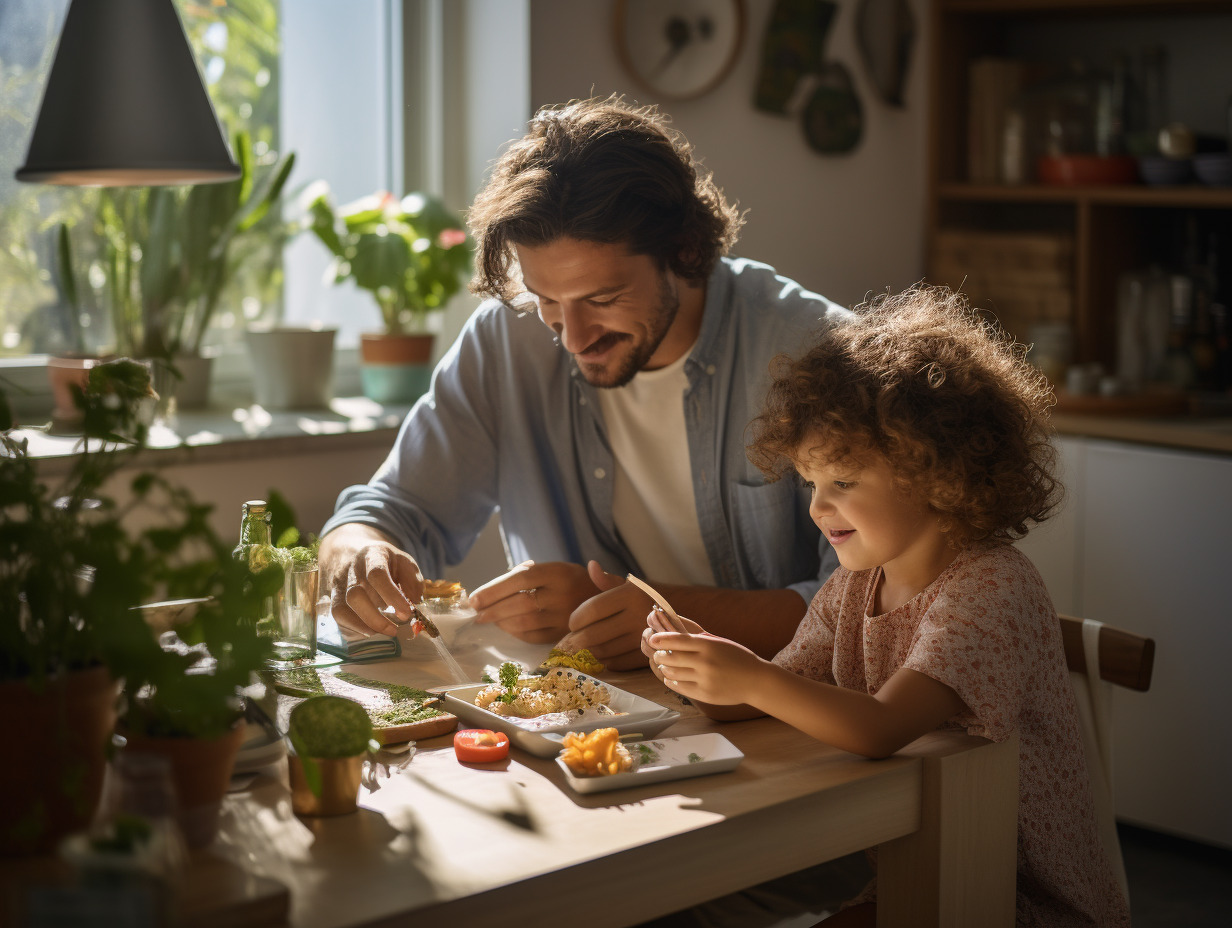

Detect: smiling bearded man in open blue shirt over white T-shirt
320,97,846,669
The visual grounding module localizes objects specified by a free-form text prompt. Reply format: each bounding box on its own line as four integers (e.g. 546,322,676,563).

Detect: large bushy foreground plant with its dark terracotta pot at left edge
0,359,281,853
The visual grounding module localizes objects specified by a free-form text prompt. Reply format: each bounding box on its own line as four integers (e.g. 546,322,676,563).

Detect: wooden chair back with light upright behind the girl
1057,615,1154,902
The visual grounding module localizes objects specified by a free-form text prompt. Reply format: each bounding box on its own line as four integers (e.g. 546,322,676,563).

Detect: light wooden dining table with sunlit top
191,616,1018,928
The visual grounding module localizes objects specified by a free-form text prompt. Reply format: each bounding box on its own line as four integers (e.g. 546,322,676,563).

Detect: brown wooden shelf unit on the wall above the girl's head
925,0,1232,371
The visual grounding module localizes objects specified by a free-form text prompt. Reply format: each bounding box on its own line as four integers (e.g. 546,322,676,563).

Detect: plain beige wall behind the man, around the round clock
531,0,928,304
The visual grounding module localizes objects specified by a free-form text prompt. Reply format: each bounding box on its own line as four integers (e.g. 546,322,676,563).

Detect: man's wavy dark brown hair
467,95,743,302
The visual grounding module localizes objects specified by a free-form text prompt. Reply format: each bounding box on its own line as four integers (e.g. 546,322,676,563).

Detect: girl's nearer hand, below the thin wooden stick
643,622,766,706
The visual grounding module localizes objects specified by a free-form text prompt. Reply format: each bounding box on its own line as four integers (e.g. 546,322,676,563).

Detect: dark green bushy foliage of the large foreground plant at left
0,359,282,737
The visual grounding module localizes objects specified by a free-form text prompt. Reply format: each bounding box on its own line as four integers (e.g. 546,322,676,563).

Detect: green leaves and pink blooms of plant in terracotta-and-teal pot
304,181,472,334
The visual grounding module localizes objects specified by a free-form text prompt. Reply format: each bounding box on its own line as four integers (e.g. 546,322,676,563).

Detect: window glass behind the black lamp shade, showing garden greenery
0,0,282,357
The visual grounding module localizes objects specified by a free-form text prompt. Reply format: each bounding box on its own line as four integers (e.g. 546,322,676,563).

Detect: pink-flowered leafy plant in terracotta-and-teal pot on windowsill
307,184,472,403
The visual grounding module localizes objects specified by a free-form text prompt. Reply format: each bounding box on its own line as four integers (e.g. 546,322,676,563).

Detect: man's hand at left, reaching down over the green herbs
318,524,424,635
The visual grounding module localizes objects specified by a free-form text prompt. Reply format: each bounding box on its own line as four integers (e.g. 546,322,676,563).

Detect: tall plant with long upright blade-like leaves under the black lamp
58,132,294,408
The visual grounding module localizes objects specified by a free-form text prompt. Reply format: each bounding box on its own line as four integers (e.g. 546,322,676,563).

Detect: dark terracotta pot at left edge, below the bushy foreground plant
0,667,120,854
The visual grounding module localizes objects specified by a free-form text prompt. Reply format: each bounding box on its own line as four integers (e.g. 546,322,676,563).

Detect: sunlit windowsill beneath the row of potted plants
17,397,410,474
